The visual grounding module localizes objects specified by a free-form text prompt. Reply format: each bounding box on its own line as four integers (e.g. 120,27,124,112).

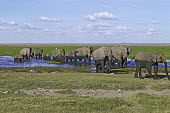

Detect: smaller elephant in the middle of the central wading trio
65,50,77,63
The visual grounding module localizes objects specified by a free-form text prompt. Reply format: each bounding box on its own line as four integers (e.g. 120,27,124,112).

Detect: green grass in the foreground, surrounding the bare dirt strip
0,72,170,113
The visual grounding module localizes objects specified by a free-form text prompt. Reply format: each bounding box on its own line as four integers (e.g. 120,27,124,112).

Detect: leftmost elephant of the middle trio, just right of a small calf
53,49,65,62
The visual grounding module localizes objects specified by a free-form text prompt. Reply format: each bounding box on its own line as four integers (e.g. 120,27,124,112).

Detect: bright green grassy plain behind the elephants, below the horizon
0,45,170,59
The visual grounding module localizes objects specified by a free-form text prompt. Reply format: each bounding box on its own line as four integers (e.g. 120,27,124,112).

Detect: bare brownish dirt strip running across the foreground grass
16,88,170,97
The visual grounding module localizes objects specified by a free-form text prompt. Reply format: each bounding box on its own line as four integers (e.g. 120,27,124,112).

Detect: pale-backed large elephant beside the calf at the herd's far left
20,48,32,60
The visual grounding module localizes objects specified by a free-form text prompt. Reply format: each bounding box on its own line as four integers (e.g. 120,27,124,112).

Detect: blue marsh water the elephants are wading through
0,56,170,68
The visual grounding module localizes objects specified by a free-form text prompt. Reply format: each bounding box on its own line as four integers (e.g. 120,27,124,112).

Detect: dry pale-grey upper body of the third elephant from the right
92,47,112,60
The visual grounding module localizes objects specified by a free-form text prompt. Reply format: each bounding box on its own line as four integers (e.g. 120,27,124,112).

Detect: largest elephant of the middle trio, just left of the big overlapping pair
76,47,93,64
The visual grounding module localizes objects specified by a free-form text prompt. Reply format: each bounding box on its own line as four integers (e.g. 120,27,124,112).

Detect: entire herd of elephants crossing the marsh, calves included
14,46,169,79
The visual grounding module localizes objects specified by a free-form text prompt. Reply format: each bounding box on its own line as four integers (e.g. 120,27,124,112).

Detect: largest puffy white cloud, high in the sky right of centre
85,12,118,21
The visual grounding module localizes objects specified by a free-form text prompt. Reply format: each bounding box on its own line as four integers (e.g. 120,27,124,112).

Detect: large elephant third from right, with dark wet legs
92,47,112,73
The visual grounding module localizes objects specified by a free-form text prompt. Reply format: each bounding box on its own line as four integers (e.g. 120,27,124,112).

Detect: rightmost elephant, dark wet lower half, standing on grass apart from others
134,51,169,79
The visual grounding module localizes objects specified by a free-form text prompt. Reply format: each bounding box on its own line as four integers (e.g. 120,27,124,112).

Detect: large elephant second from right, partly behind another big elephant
111,46,132,68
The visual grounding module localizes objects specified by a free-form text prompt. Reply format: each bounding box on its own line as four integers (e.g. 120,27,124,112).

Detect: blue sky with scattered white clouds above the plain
0,0,170,43
